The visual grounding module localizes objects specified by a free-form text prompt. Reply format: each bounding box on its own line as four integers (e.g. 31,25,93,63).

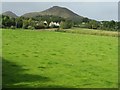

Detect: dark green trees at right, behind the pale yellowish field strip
79,19,120,31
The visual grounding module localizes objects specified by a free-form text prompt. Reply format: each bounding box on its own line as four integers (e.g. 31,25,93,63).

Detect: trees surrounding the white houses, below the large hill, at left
0,15,73,29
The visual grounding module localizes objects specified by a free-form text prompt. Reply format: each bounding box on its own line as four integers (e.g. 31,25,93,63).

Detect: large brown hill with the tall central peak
22,6,83,20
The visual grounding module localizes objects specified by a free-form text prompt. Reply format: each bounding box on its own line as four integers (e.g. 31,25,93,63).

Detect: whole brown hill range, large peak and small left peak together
2,6,84,22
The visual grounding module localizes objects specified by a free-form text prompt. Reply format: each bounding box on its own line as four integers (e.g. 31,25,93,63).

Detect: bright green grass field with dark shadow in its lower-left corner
2,30,118,88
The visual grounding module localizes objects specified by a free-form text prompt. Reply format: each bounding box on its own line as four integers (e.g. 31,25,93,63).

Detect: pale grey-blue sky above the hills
2,2,118,21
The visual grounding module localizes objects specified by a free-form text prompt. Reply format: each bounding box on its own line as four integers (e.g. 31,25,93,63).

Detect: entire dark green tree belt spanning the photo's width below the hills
0,15,120,31
